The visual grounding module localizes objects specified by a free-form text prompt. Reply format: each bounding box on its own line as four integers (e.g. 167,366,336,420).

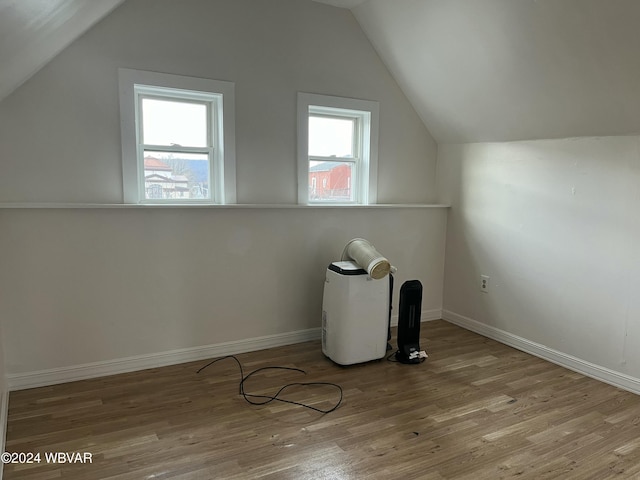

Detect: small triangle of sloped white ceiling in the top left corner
0,0,123,100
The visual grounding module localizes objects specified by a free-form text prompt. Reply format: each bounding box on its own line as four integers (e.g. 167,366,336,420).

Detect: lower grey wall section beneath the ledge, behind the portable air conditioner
0,208,446,376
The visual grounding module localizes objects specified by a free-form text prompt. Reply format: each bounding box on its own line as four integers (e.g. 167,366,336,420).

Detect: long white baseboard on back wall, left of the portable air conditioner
5,328,320,392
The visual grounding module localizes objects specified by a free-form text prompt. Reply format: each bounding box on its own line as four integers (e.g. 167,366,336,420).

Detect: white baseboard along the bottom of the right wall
442,310,640,395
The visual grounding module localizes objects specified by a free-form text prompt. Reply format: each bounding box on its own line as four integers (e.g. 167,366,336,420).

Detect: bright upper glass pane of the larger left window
142,98,207,147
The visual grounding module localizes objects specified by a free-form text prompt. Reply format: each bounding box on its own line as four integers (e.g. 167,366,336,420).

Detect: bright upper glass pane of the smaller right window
309,115,354,157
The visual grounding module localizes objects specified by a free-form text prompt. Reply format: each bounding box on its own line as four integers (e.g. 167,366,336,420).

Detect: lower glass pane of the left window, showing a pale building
144,150,211,200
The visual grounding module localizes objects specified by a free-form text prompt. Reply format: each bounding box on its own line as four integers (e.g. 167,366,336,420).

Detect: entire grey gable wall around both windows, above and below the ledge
0,0,446,378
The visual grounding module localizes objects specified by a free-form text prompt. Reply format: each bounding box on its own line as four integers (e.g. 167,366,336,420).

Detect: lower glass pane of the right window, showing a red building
309,162,355,202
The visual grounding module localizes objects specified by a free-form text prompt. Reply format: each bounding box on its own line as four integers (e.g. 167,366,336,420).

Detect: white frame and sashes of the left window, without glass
118,68,236,205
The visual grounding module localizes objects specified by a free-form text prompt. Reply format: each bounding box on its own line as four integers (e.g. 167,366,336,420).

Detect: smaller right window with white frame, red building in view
298,93,379,205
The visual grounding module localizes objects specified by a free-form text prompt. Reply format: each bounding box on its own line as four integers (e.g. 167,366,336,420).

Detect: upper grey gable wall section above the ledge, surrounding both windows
0,0,436,203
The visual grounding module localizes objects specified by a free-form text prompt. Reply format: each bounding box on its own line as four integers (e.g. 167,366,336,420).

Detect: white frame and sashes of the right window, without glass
297,92,380,205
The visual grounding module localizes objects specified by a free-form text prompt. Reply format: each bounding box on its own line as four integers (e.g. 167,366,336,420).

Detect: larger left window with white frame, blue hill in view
119,69,235,204
